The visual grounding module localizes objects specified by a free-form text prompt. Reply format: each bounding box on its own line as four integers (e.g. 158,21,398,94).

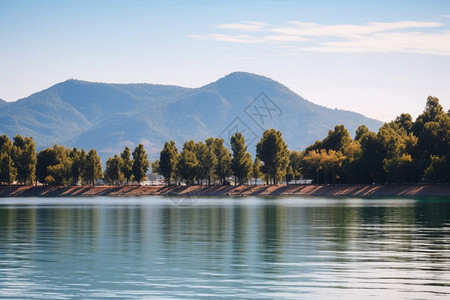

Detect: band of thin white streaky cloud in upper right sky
190,21,450,55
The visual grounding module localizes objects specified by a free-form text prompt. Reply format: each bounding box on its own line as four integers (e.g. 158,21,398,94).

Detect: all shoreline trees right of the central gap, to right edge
152,96,450,184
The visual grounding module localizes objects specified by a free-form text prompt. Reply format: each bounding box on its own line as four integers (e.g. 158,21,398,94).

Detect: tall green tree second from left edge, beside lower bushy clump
12,135,36,185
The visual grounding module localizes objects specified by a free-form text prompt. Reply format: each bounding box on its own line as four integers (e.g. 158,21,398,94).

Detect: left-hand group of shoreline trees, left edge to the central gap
0,135,149,186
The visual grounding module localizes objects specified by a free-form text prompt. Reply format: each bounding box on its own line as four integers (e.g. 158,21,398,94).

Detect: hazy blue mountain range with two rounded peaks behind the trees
0,72,382,160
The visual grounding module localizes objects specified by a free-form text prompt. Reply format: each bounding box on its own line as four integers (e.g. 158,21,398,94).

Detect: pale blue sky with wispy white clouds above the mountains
0,0,450,122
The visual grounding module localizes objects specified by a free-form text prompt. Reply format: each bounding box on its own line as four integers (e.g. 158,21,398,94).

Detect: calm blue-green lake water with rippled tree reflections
0,197,450,299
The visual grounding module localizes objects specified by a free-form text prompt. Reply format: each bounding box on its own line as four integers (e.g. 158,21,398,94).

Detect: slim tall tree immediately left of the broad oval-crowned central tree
230,132,253,184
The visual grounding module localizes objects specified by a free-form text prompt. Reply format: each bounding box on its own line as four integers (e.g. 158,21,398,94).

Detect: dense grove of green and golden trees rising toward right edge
294,96,450,183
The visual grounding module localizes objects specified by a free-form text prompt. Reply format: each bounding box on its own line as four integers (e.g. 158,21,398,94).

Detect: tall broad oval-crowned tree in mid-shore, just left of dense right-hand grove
256,129,289,184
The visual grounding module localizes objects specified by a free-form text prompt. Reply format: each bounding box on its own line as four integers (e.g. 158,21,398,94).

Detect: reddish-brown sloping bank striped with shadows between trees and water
0,184,450,201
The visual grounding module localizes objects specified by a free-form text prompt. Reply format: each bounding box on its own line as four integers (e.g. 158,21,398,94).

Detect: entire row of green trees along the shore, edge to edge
0,96,450,185
